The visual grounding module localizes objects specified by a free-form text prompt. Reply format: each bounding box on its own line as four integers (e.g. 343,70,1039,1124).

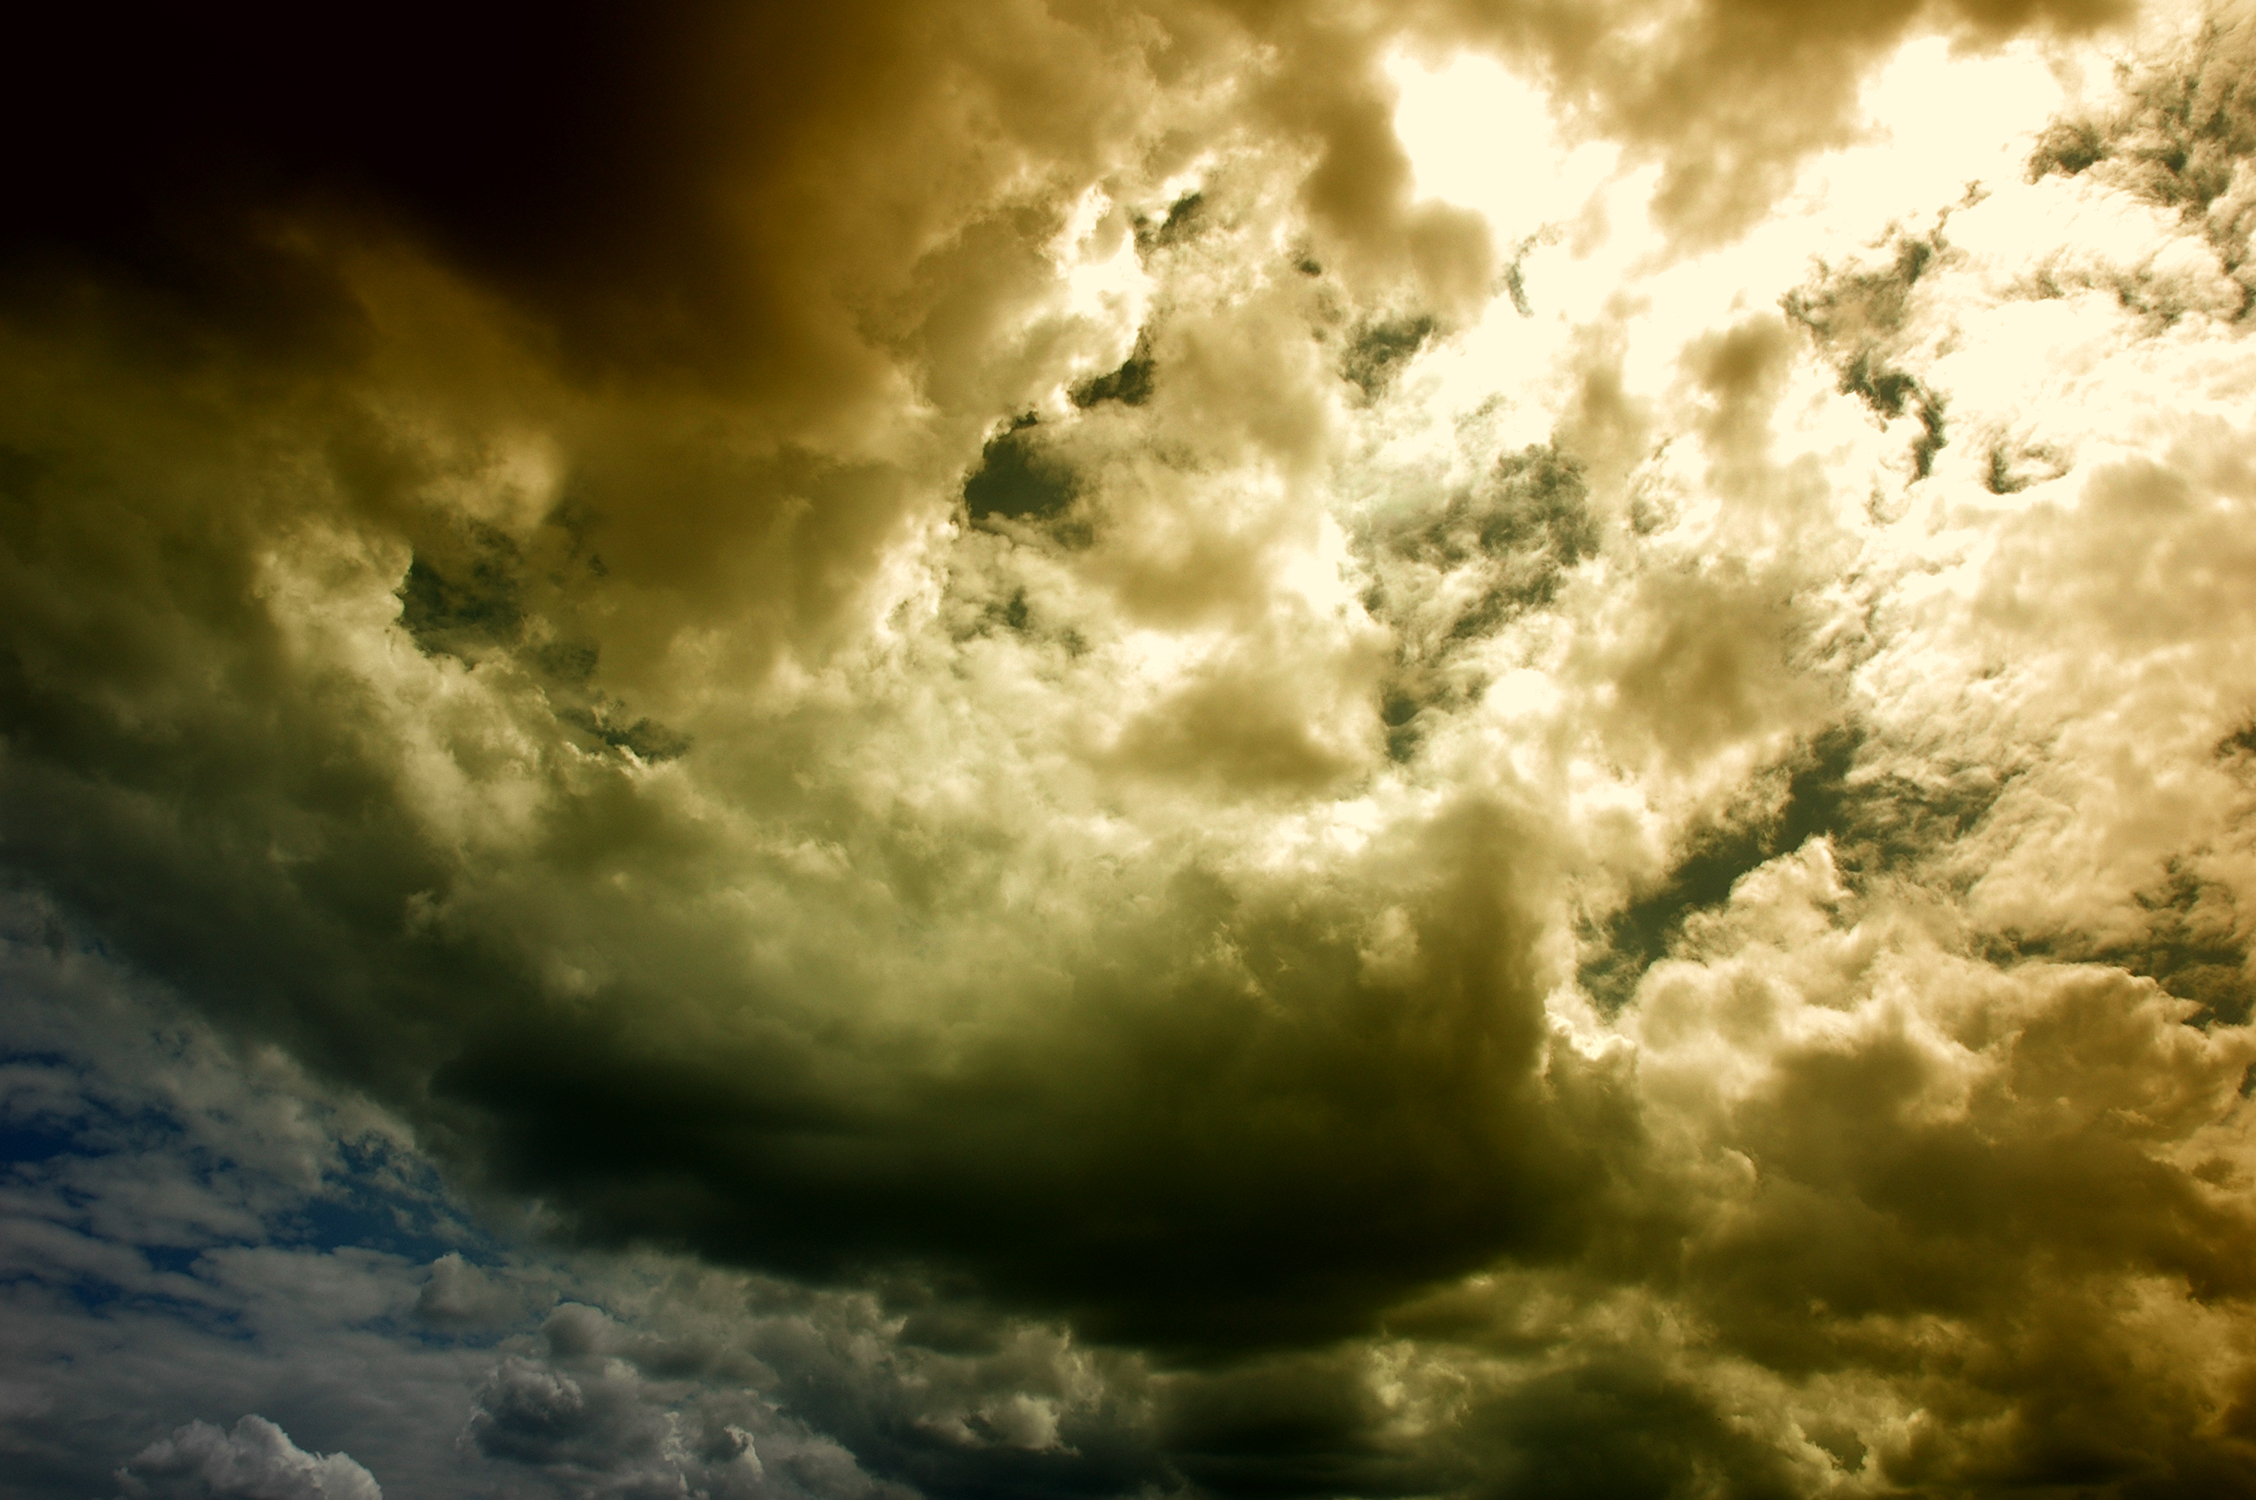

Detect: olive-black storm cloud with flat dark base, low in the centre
410,810,1620,1349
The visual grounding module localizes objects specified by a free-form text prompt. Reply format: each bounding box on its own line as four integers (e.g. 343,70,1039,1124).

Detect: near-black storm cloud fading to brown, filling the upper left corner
7,5,1207,713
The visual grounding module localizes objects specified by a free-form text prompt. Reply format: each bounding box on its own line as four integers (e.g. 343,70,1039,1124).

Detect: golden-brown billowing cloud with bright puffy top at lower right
1638,846,2249,1484
